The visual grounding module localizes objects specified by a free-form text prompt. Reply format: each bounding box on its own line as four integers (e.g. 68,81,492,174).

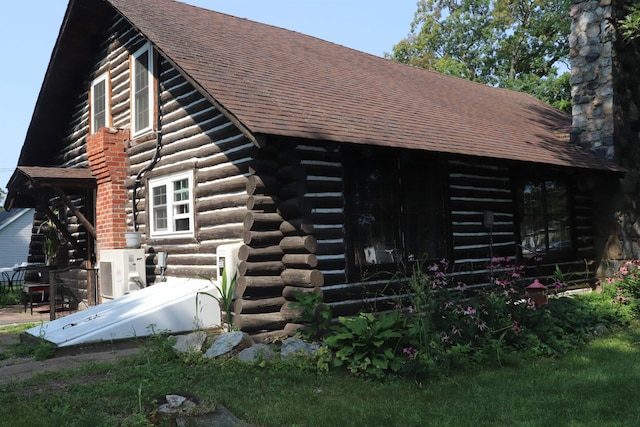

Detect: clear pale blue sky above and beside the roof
0,0,417,194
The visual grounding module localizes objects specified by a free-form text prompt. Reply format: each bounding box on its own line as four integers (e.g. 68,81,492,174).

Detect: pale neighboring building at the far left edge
0,208,34,267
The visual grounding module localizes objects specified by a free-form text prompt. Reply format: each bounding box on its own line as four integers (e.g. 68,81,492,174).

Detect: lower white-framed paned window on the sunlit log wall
149,172,194,236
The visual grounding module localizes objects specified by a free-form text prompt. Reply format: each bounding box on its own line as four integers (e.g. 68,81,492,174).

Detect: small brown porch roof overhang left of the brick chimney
4,166,96,210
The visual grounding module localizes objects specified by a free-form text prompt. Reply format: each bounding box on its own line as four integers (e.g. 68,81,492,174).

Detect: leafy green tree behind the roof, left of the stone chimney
387,0,571,111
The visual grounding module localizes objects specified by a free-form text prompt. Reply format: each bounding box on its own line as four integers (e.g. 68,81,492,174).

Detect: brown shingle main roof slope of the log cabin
104,0,613,169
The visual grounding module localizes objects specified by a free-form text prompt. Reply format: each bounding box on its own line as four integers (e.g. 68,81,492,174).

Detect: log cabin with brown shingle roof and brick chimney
5,0,624,337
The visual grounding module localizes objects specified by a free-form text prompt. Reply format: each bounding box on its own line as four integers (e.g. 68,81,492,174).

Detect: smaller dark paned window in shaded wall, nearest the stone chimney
519,179,572,257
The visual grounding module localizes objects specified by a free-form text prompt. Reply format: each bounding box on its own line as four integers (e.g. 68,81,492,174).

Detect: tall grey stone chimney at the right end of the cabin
569,0,640,264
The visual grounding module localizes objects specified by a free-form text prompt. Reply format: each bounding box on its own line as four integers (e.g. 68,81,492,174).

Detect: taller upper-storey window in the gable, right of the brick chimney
131,44,154,136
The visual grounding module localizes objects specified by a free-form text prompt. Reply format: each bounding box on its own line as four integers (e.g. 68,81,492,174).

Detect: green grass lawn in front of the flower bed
0,324,640,427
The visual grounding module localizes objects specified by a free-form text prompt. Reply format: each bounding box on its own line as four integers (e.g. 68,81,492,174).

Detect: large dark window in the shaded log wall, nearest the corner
345,148,445,280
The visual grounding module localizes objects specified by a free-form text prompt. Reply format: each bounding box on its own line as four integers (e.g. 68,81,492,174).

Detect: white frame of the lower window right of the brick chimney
147,171,195,237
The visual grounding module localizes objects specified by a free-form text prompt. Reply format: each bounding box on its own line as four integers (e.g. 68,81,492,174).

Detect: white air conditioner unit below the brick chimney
100,249,147,299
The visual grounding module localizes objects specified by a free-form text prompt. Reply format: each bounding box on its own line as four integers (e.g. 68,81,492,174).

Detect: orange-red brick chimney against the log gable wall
86,128,129,250
